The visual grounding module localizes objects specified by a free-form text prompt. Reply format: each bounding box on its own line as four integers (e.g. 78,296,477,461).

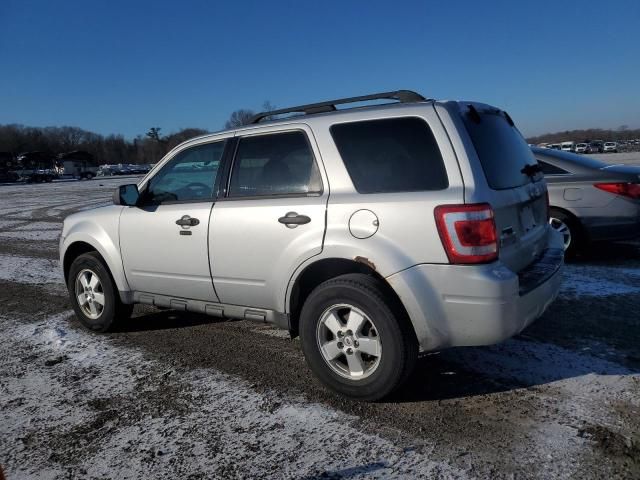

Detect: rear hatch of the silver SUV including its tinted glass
459,102,549,272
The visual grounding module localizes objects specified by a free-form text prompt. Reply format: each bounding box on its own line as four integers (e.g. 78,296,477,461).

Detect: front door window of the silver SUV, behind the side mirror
144,141,225,205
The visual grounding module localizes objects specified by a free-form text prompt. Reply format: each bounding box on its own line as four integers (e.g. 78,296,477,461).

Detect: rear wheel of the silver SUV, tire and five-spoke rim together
300,274,418,401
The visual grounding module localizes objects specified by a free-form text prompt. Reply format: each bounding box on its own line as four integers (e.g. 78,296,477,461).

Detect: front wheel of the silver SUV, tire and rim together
67,252,133,332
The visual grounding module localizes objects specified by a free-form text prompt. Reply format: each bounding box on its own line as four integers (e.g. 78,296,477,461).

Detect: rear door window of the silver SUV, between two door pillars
229,131,322,197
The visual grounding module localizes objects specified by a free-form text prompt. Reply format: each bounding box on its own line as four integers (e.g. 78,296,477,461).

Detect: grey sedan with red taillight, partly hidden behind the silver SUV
532,147,640,255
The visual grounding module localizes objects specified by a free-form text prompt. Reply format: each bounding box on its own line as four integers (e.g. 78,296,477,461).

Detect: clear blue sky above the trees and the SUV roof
0,0,640,137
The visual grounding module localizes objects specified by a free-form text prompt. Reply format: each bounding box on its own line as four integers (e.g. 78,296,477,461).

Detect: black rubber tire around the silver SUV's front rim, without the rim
67,252,133,332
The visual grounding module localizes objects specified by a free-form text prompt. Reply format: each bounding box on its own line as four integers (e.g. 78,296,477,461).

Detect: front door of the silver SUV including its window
120,140,225,301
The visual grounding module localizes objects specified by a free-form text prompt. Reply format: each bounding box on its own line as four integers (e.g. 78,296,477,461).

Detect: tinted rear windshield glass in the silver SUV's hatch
462,106,536,190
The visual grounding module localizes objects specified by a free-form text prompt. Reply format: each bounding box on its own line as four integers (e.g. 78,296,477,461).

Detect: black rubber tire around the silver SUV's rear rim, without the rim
300,274,418,401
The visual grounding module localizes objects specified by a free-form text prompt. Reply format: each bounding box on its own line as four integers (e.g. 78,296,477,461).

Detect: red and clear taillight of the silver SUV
434,203,498,264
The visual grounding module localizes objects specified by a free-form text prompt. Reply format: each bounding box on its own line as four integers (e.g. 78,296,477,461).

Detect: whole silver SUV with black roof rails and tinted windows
60,91,563,400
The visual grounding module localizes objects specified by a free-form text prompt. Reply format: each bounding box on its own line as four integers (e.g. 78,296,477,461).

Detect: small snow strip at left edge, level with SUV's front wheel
0,254,64,284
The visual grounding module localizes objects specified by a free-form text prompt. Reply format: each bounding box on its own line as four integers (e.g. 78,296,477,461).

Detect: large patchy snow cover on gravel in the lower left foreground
0,312,466,479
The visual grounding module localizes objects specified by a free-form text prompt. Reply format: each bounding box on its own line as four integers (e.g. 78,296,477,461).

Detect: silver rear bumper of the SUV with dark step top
387,233,563,351
